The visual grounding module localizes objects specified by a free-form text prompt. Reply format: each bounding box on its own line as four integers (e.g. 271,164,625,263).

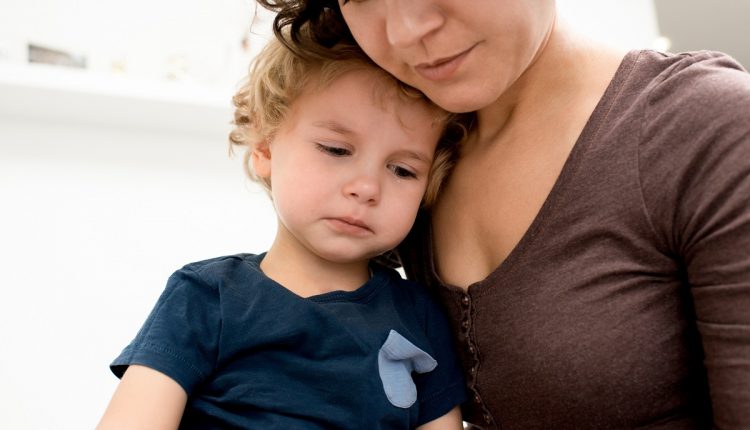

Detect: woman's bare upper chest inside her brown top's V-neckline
432,136,568,288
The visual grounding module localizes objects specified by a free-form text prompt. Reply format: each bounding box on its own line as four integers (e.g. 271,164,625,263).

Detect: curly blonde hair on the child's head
229,39,466,207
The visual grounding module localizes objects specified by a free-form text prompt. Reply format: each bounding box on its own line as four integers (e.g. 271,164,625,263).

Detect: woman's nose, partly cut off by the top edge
385,0,444,48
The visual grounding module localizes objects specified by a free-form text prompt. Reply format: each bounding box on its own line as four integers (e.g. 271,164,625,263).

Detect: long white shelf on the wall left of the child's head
0,63,234,135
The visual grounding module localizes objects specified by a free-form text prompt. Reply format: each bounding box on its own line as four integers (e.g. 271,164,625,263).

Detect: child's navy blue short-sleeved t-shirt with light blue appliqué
111,254,465,430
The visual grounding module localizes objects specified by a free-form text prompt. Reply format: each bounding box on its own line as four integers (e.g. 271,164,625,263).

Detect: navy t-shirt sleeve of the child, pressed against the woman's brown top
414,287,466,425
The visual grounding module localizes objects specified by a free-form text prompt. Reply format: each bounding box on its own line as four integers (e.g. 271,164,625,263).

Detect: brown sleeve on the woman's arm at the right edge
639,52,750,429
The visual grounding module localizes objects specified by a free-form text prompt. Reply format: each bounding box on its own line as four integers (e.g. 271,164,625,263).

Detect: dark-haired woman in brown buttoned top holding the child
259,0,750,430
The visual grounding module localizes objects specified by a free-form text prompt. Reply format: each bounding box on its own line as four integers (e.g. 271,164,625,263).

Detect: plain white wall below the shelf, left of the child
0,116,275,429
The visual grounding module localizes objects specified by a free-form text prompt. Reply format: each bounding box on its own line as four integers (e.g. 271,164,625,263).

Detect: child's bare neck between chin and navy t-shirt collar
260,244,370,297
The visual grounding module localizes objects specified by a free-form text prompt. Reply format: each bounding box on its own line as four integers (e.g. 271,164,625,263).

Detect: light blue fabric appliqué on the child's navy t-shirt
378,330,437,409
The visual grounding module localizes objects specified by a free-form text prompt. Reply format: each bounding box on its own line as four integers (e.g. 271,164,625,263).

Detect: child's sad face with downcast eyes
253,70,442,263
